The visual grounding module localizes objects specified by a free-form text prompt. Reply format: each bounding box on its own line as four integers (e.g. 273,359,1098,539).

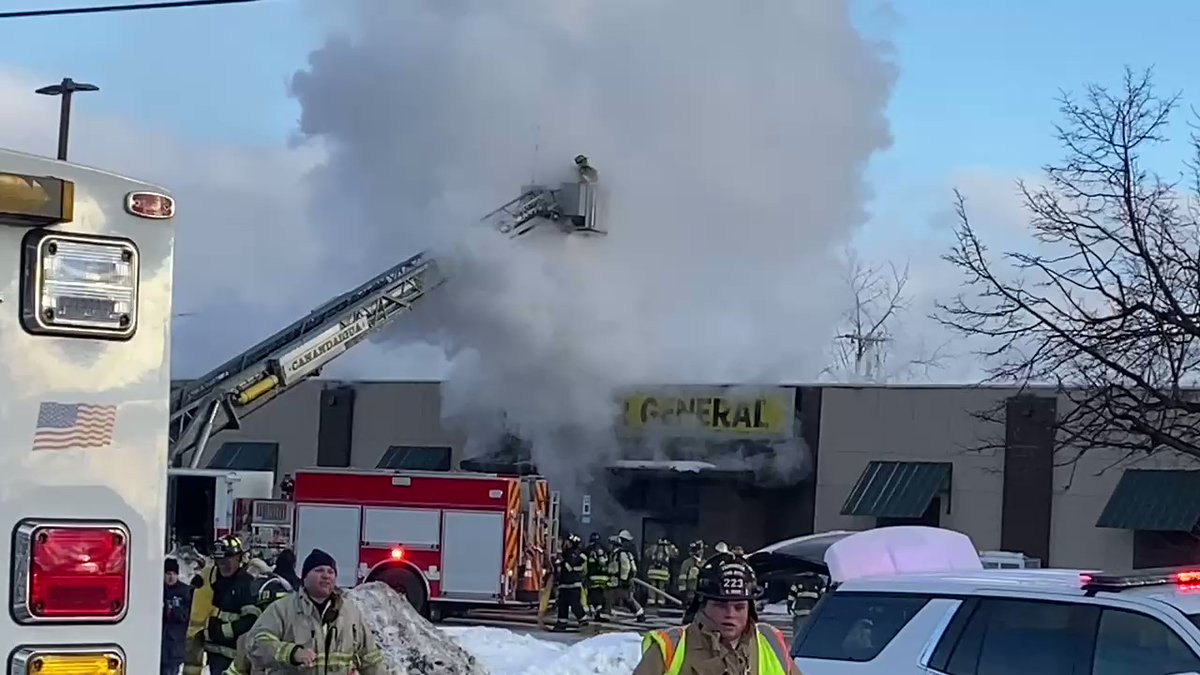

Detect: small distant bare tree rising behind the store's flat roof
823,249,938,382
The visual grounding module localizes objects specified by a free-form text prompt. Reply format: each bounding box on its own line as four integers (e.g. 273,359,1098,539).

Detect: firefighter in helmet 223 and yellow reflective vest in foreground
634,560,799,675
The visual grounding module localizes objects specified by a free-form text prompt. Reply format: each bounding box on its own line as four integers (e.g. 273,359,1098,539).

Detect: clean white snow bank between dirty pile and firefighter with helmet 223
443,627,641,675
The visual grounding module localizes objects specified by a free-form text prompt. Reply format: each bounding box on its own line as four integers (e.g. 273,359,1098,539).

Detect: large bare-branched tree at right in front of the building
938,71,1200,461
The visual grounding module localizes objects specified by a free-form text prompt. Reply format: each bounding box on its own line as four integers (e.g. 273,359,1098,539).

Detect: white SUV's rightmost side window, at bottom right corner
1092,609,1200,675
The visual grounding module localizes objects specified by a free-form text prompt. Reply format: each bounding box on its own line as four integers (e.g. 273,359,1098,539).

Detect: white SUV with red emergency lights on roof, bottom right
792,527,1200,675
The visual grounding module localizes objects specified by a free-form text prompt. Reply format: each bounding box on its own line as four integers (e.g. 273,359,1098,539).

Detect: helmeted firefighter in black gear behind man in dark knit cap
204,536,263,675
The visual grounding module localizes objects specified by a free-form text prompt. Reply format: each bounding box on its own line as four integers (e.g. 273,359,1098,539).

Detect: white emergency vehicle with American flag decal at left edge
0,150,175,675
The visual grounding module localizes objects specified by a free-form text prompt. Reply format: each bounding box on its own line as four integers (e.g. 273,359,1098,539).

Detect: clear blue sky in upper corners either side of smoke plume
0,0,1200,229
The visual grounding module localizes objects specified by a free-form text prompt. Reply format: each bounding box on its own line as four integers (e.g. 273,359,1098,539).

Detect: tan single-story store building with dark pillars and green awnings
187,381,1200,568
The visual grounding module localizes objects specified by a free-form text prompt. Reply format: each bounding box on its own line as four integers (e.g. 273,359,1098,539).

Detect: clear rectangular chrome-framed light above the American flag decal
22,231,138,340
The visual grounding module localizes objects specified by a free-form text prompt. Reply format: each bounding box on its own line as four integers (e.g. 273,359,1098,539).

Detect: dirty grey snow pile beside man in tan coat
346,581,487,675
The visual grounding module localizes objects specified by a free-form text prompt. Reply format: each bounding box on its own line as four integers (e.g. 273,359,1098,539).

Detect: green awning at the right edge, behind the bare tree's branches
1096,468,1200,532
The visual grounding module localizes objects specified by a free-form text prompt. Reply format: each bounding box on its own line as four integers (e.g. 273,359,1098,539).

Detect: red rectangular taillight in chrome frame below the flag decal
12,520,130,619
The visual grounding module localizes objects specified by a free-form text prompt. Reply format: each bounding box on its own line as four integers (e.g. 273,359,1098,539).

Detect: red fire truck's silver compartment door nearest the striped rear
442,510,504,599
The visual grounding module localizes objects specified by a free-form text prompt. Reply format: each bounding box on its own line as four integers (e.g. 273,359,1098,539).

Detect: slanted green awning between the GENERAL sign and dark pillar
841,461,953,518
